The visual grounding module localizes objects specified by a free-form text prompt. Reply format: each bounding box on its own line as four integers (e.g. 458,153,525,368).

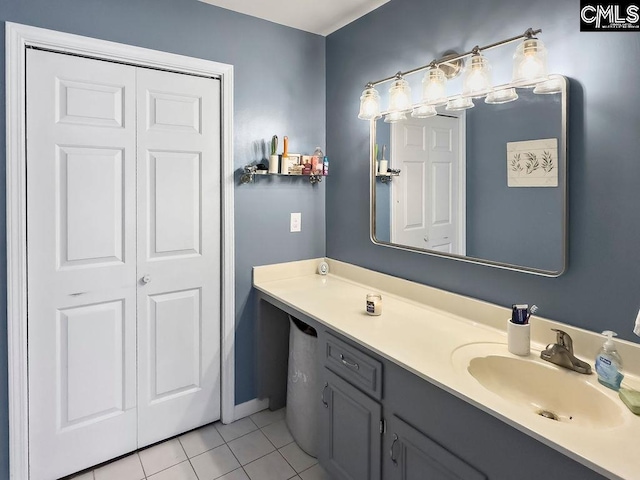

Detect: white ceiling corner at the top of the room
200,0,389,36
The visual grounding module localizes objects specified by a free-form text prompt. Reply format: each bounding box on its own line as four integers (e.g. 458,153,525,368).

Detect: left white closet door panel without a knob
27,50,136,480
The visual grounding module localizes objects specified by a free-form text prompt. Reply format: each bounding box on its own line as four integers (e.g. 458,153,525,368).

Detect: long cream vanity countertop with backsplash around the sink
253,259,640,479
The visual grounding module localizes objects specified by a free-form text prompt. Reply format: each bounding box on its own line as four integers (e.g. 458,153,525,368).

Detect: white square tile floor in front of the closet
65,409,331,480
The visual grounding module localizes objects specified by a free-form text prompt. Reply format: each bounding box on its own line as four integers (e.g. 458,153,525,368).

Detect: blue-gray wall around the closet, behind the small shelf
0,0,324,472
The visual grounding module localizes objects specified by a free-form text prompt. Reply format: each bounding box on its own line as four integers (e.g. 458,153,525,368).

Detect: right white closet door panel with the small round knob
137,69,220,446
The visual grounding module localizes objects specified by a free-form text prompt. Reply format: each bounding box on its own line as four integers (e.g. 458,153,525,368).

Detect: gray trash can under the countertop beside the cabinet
285,315,319,457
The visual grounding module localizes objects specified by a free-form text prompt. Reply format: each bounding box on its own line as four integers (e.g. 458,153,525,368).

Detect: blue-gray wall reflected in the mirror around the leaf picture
466,89,564,272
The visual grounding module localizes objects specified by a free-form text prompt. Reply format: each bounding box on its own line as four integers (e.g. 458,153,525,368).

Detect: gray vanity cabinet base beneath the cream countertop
254,297,604,480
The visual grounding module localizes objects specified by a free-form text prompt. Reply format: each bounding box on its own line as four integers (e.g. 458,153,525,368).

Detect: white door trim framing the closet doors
5,22,235,480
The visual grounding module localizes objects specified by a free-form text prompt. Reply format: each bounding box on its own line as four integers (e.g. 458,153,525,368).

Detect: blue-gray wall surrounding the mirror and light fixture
327,0,640,342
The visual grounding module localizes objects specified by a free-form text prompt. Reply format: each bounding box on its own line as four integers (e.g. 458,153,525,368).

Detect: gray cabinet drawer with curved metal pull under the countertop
324,332,382,400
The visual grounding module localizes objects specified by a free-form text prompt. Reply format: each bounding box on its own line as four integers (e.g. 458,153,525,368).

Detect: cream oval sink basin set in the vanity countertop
452,343,624,428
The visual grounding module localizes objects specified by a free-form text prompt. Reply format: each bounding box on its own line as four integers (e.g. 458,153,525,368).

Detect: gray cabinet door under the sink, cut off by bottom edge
384,415,487,480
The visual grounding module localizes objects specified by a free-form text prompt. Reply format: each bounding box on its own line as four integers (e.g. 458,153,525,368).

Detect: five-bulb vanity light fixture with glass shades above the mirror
358,28,548,123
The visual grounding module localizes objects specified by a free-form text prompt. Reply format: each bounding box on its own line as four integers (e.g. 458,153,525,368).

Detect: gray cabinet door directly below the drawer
319,368,382,480
